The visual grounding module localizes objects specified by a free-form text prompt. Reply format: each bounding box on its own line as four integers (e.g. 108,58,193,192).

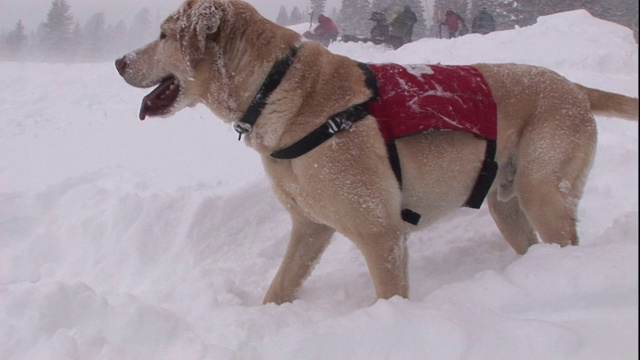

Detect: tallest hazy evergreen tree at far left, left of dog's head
41,0,74,60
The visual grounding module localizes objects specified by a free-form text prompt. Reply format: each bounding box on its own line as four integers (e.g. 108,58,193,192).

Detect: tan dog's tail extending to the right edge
576,84,638,121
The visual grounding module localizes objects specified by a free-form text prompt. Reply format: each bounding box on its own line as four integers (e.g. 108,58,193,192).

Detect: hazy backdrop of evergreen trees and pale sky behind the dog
0,0,639,63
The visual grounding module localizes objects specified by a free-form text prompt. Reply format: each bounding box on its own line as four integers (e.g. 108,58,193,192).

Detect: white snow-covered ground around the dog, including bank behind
0,11,638,360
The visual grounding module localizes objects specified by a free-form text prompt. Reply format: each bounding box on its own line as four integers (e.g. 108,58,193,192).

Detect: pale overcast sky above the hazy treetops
0,0,350,32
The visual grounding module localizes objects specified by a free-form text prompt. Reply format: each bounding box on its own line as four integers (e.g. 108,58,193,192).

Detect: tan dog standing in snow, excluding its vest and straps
116,0,638,303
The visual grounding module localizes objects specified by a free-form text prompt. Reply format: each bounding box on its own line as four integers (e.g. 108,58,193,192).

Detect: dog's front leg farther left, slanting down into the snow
263,216,335,304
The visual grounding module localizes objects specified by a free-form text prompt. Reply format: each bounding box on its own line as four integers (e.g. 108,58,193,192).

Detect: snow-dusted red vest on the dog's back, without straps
368,64,497,141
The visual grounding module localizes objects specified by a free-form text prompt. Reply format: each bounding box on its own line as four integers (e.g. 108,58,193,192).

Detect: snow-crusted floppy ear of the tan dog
178,1,222,66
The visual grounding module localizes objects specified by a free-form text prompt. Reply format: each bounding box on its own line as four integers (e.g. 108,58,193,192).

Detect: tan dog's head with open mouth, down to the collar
116,0,297,120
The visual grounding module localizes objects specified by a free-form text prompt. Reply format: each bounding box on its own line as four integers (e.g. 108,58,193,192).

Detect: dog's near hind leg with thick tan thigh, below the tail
514,114,596,246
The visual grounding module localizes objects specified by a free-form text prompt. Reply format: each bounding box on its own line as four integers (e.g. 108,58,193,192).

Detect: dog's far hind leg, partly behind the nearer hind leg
487,189,538,255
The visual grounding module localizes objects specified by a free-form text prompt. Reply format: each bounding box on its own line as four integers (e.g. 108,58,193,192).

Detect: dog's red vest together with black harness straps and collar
234,48,498,225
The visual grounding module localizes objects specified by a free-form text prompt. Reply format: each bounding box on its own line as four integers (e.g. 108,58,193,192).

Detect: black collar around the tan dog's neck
233,46,298,140
